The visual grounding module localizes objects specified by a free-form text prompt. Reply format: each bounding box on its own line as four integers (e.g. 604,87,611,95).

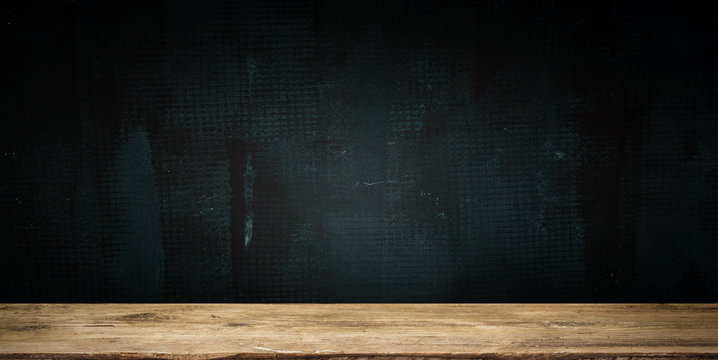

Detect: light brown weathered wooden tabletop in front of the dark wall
0,304,718,359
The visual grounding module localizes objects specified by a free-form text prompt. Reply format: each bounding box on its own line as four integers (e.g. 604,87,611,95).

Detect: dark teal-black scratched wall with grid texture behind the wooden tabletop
0,0,718,302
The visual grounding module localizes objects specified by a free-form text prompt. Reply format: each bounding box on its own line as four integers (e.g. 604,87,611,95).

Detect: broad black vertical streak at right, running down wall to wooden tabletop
566,4,647,301
